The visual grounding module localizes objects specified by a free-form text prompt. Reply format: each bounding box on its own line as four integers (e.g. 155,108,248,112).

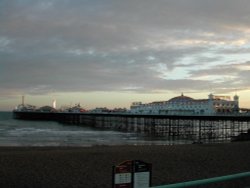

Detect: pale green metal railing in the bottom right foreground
152,172,250,188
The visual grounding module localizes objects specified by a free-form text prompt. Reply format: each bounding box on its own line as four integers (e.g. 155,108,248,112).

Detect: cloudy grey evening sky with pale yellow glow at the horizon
0,0,250,110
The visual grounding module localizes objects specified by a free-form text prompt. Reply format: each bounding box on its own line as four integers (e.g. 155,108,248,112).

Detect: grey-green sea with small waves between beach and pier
0,112,186,147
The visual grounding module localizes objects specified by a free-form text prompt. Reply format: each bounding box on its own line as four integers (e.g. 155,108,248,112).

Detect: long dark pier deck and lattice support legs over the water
13,111,250,143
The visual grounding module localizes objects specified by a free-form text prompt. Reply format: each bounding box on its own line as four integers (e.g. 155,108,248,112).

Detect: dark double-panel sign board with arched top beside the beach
112,160,152,188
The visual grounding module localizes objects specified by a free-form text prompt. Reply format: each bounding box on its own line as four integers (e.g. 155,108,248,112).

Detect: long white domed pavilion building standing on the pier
130,94,239,115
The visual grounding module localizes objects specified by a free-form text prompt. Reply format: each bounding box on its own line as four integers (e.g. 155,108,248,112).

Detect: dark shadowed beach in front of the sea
0,142,250,188
